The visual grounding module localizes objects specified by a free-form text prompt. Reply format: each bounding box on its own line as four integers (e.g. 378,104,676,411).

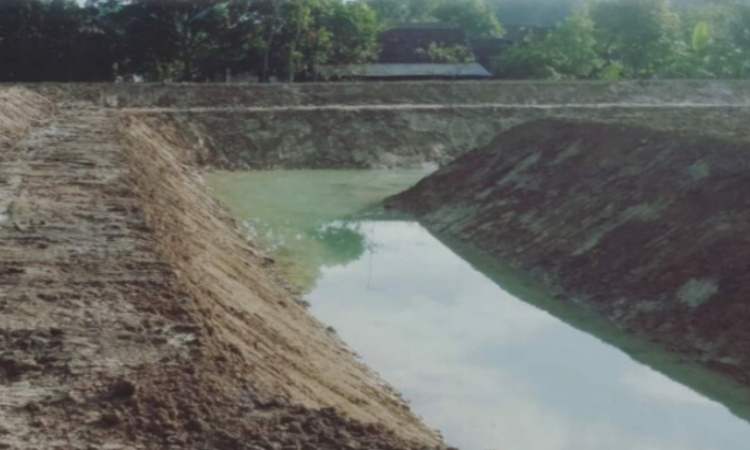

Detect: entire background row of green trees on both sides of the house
0,0,750,82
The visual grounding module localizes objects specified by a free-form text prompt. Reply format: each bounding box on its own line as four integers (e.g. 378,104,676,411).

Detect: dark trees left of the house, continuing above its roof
0,0,502,81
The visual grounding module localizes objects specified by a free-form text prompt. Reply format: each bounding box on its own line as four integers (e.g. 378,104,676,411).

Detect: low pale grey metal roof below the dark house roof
318,62,492,78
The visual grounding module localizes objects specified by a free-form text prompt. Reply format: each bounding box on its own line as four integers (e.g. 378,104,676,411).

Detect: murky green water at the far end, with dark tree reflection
207,169,429,293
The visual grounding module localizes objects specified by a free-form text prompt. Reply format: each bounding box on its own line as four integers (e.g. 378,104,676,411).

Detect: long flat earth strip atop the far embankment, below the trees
29,80,750,108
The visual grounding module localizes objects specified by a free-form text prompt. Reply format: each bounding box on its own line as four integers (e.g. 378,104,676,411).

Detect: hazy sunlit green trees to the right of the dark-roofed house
493,0,750,79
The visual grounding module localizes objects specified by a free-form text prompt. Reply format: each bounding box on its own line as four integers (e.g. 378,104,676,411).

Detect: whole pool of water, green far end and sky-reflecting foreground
208,171,750,450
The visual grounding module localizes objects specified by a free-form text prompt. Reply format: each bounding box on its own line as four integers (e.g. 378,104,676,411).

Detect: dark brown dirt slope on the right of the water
387,121,750,385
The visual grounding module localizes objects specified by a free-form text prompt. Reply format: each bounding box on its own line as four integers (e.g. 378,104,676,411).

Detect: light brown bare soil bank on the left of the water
0,90,440,450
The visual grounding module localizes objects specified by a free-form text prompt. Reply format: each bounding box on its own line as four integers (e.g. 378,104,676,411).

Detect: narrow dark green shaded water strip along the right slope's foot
425,226,750,428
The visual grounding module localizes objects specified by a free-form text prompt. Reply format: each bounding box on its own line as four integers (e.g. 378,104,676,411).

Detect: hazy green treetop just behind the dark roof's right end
432,0,503,37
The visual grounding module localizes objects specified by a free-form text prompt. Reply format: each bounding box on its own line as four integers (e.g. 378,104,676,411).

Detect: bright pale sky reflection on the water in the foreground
307,221,750,450
